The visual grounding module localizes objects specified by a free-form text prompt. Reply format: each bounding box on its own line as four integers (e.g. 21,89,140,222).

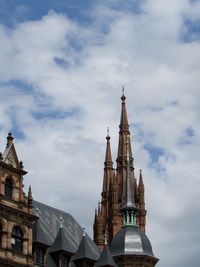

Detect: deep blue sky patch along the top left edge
0,0,93,27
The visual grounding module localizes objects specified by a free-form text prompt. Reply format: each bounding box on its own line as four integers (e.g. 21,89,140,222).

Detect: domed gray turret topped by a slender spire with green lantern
111,140,158,267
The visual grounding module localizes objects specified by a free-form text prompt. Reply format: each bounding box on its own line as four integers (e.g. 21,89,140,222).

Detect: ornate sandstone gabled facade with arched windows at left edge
0,133,37,267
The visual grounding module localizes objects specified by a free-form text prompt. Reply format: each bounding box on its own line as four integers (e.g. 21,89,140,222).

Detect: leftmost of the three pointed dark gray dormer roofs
49,228,76,254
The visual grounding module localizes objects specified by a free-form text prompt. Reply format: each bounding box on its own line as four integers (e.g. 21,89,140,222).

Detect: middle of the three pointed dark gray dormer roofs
73,236,99,261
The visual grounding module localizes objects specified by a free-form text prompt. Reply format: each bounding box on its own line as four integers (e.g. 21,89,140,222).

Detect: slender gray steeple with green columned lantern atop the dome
122,137,138,226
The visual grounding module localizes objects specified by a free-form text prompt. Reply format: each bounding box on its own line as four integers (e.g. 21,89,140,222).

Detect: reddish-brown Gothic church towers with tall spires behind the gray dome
93,90,146,250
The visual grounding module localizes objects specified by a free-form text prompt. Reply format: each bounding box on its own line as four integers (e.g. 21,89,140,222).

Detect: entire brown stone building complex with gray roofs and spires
0,93,158,267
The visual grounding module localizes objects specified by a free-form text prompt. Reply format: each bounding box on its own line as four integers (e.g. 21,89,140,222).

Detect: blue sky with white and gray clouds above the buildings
0,0,200,267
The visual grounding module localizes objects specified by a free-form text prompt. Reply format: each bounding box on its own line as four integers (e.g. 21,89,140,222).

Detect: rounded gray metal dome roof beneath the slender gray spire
110,225,154,257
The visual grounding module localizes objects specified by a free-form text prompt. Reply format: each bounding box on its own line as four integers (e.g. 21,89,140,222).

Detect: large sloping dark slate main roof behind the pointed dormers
33,201,99,267
